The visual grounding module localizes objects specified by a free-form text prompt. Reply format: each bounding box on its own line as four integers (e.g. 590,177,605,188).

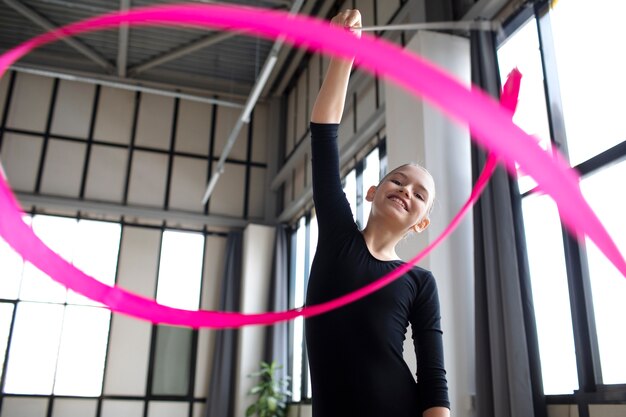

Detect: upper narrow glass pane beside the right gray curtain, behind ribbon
498,19,550,193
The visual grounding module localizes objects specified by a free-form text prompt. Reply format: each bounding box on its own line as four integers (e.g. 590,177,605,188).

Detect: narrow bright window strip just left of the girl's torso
291,217,306,401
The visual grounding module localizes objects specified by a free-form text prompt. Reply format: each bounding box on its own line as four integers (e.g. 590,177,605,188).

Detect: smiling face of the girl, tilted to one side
366,165,435,233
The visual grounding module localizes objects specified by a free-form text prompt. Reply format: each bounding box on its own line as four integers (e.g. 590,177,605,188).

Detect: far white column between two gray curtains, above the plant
235,224,275,416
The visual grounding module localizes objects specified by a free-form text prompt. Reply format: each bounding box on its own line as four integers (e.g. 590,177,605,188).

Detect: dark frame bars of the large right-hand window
498,0,626,417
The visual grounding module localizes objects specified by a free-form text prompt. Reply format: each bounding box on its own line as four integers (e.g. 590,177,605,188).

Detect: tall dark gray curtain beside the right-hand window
471,31,546,417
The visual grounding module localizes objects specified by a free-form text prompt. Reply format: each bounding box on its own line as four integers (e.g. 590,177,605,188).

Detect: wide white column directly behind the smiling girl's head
385,31,475,417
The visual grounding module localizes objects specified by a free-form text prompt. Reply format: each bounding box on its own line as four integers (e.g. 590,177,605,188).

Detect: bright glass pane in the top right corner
550,0,626,165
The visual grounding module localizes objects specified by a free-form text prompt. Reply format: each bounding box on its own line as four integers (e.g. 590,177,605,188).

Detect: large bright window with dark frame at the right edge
498,0,626,402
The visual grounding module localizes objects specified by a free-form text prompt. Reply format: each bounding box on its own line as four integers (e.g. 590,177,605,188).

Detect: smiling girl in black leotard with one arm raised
306,10,450,417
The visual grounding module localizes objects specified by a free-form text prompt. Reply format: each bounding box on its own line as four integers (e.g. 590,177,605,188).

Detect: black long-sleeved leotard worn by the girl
305,123,450,417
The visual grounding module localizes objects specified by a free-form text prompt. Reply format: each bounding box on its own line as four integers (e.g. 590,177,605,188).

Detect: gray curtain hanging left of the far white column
204,231,243,417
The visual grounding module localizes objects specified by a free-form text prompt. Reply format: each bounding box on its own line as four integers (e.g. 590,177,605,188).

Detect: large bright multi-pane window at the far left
0,215,121,396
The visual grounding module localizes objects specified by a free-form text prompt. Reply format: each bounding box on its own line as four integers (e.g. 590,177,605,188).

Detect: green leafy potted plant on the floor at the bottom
246,362,291,417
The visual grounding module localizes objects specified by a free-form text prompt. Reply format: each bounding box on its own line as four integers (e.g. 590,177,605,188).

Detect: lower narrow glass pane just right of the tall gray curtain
522,194,578,395
